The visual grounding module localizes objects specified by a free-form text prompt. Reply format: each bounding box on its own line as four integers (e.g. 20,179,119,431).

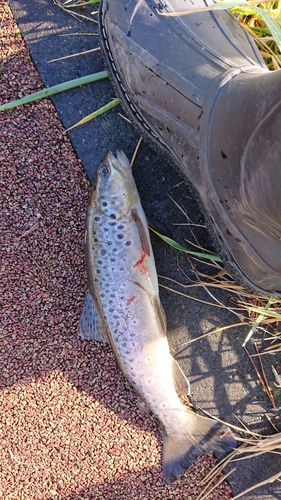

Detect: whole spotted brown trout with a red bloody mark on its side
80,151,236,484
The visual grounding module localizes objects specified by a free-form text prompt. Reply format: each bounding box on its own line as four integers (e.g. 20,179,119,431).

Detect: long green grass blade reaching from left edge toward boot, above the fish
0,71,108,111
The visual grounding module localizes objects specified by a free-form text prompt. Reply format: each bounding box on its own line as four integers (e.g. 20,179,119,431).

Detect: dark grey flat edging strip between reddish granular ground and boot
9,0,281,500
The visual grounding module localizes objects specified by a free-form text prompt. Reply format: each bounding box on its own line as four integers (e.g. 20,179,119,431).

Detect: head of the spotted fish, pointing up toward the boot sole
90,151,138,219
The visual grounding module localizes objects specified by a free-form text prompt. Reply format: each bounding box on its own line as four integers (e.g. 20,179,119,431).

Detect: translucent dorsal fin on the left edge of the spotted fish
80,293,108,344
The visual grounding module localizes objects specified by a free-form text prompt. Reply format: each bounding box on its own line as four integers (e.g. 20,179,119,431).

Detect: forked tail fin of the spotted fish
163,410,237,484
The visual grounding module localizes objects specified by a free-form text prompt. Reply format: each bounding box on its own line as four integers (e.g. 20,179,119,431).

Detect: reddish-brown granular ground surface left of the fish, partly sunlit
0,0,231,500
